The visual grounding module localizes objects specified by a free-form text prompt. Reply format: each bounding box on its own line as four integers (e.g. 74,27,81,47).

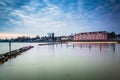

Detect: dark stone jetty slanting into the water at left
0,46,33,64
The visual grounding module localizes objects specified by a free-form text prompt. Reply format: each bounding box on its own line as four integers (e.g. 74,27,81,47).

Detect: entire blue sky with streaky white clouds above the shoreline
0,0,120,36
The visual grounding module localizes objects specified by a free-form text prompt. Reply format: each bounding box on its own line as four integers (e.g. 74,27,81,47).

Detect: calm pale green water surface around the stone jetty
0,43,120,80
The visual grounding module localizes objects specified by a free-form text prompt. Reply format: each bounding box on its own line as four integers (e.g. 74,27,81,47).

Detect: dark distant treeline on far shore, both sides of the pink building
0,32,120,42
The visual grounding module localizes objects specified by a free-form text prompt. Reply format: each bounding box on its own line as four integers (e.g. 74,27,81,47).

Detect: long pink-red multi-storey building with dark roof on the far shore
73,31,108,41
